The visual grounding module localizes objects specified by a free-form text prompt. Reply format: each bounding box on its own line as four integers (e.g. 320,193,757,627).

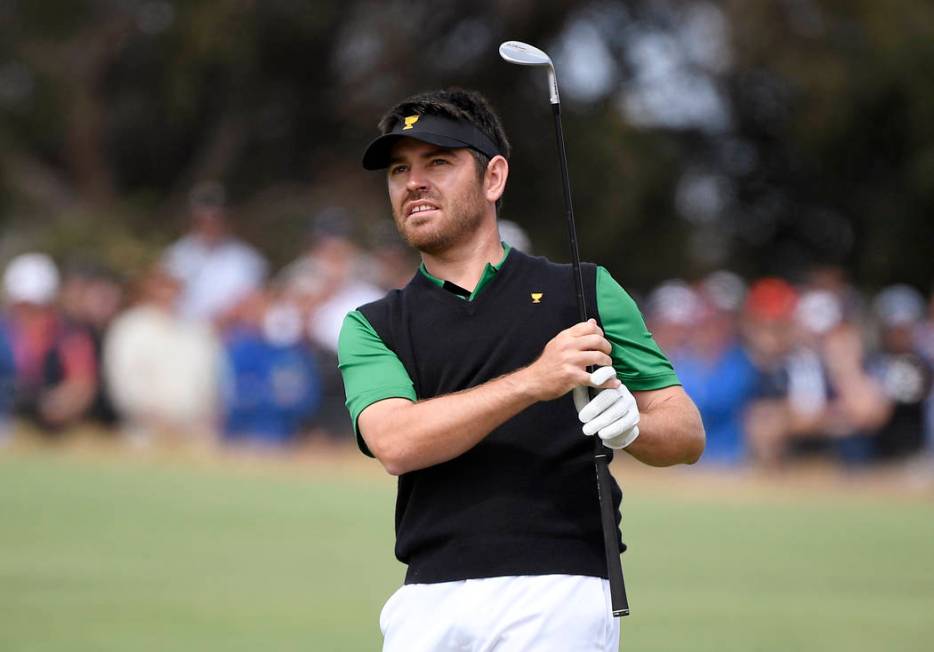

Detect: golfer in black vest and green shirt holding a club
338,90,704,652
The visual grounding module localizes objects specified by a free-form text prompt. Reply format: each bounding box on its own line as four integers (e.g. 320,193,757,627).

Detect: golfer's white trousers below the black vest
379,575,619,652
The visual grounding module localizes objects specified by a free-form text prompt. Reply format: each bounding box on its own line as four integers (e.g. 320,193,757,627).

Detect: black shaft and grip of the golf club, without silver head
551,102,629,616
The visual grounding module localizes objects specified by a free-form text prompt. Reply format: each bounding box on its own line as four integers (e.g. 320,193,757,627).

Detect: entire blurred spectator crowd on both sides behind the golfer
0,184,934,467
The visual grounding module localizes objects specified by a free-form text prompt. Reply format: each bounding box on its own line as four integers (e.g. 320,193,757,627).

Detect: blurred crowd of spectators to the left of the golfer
0,184,417,448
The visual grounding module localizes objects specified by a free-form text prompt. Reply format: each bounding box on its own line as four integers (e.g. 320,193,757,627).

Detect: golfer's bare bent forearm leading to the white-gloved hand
625,388,705,466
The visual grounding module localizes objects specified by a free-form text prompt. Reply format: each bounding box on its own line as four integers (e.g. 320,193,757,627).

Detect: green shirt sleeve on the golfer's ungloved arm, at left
337,310,416,457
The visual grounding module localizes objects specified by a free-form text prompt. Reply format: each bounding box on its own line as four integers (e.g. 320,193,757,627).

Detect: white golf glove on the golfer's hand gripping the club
574,367,639,450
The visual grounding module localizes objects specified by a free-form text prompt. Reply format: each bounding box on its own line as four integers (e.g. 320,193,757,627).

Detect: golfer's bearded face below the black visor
387,138,495,254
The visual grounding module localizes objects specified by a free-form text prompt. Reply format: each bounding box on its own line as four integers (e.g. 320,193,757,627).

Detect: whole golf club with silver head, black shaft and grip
499,41,629,617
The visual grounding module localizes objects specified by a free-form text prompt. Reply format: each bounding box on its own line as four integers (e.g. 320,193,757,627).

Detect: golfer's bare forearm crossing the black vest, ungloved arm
358,369,536,475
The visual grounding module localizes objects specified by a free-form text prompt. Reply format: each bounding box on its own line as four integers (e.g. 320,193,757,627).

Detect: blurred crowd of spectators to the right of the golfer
645,267,934,468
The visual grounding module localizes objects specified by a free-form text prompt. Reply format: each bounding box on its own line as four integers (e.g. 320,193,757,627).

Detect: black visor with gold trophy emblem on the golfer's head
363,114,501,170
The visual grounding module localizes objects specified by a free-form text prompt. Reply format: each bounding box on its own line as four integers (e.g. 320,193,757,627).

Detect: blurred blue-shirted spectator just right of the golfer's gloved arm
672,272,758,465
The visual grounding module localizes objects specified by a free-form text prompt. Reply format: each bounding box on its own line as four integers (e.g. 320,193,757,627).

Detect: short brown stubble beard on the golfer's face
394,187,484,255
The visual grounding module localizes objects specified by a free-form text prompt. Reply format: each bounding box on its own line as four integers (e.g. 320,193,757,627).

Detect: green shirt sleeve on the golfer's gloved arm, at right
597,267,681,392
